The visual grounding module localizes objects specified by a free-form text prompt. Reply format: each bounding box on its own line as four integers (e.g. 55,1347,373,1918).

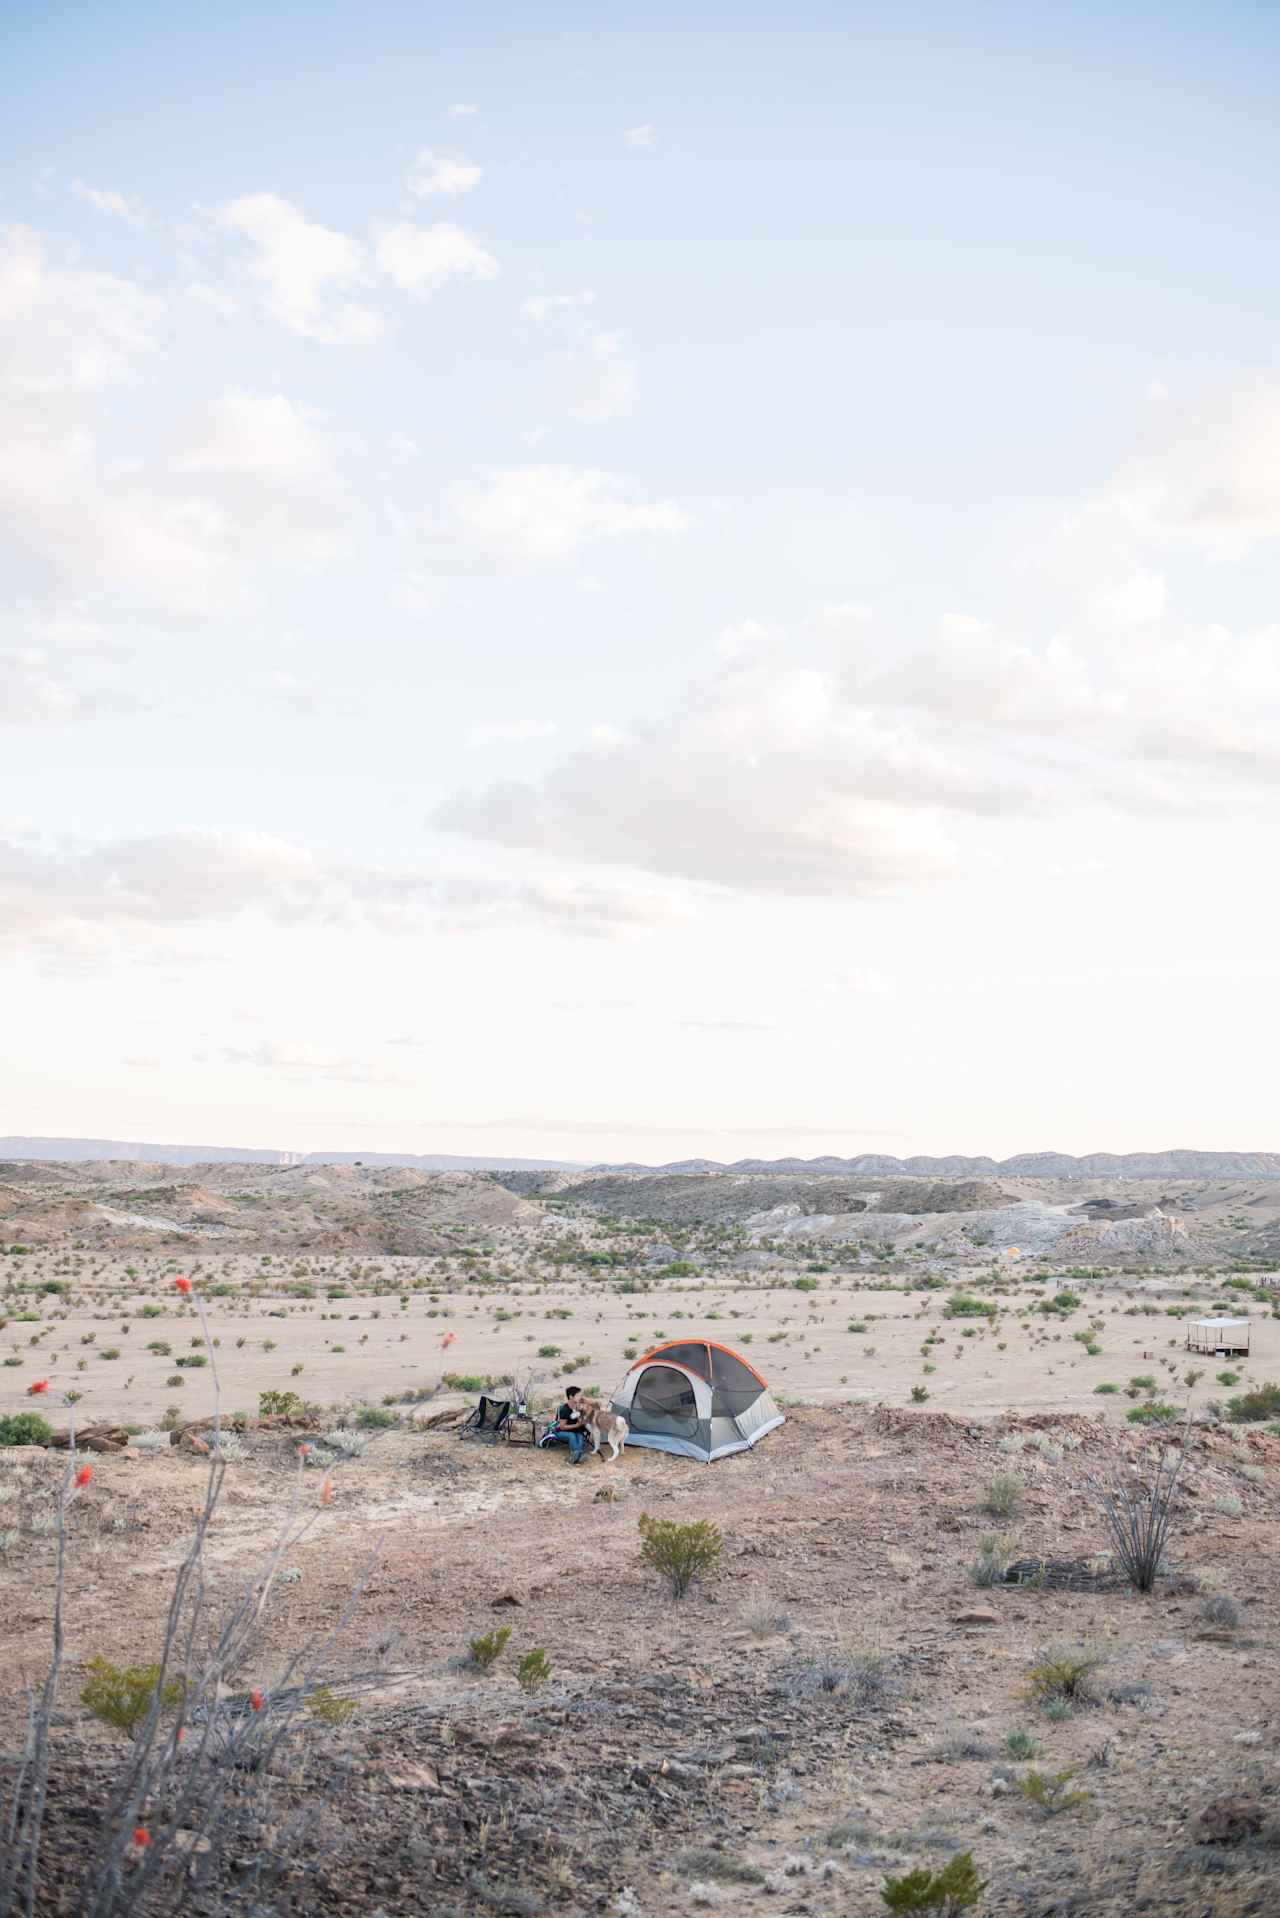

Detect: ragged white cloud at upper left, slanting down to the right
219,194,382,345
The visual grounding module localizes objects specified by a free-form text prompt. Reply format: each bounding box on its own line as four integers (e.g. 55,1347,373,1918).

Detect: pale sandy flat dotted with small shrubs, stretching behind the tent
0,1256,1280,1425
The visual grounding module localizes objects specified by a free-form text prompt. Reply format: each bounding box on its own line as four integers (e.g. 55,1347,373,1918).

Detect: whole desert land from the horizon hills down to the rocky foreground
0,1164,1280,1918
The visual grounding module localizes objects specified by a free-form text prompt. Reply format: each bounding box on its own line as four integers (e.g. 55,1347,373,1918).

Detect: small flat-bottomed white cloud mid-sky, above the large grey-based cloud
434,466,691,572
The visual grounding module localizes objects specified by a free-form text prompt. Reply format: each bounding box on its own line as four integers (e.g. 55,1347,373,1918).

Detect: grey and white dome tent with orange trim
614,1339,783,1465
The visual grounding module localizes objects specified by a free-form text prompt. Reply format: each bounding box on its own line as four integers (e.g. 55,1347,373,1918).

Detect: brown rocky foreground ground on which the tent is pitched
0,1408,1280,1918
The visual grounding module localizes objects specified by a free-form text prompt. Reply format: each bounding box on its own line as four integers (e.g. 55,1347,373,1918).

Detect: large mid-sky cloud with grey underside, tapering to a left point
436,664,974,896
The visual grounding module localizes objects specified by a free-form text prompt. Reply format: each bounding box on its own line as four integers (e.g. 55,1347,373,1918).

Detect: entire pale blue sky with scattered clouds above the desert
0,0,1280,1162
